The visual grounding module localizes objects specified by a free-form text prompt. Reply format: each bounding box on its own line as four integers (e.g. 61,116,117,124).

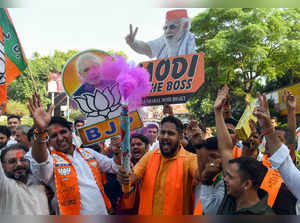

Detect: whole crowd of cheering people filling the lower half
0,86,300,215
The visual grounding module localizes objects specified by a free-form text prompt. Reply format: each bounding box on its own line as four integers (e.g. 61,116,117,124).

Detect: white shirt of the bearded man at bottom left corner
0,164,49,215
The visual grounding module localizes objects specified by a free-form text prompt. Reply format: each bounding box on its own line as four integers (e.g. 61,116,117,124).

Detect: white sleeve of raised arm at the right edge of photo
269,144,300,200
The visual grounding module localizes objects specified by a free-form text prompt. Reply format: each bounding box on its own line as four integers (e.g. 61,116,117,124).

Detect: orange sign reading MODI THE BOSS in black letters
140,52,205,106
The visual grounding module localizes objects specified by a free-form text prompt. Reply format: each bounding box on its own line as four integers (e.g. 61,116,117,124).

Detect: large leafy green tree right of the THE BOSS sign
188,8,300,125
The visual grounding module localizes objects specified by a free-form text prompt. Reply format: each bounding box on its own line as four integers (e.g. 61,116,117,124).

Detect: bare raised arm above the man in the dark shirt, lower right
214,86,233,169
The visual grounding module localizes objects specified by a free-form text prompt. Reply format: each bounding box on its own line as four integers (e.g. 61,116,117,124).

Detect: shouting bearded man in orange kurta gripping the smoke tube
118,116,197,215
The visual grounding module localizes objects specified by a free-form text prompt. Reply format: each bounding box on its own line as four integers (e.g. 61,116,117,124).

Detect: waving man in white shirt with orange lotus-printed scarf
28,95,121,215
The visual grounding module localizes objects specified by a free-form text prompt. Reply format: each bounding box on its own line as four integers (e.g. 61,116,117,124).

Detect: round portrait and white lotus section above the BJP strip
62,50,121,125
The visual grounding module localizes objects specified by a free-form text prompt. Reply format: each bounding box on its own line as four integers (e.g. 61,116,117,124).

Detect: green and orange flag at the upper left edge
0,8,27,111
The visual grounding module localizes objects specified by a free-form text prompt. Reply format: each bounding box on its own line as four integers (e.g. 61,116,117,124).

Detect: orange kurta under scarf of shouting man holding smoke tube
133,147,198,215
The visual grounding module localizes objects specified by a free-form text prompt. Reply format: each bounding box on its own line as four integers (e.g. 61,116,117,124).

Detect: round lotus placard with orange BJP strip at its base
62,50,143,145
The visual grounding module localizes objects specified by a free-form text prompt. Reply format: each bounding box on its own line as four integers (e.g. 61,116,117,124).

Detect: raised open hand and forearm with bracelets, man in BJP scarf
27,95,54,163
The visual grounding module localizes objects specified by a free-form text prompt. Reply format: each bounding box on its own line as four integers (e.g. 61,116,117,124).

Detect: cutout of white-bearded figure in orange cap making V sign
126,9,196,59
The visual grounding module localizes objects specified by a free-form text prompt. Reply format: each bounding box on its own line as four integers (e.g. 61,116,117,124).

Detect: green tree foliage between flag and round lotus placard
7,50,127,119
